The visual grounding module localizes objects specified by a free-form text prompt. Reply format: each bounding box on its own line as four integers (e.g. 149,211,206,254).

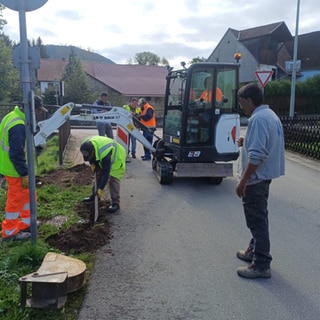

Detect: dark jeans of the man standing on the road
242,180,272,269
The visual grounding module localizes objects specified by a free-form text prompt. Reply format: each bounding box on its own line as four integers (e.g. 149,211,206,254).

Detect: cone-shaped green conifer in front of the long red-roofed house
62,51,95,103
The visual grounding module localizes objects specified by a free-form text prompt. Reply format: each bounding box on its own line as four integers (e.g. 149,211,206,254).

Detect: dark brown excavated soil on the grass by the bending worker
36,164,111,254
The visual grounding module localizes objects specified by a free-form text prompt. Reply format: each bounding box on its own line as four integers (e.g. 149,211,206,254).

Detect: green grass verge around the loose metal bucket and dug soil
0,137,94,320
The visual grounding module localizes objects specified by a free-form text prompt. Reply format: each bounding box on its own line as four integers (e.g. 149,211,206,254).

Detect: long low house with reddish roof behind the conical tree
37,59,168,113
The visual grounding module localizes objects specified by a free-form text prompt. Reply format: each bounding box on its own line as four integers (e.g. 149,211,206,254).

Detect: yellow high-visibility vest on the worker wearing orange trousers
0,106,25,178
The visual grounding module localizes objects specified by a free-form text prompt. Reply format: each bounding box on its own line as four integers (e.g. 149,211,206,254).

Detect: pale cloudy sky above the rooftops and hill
0,0,320,67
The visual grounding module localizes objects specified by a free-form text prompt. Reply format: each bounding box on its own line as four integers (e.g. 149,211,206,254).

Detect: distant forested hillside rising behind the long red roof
44,44,114,63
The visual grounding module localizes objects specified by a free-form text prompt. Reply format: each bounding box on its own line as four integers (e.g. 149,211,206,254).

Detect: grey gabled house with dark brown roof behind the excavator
207,22,292,83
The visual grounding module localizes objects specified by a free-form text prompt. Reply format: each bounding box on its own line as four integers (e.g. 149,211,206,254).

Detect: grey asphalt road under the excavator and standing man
79,131,320,320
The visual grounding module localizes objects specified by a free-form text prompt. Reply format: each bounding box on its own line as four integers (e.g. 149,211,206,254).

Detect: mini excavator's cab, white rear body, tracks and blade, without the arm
153,63,240,183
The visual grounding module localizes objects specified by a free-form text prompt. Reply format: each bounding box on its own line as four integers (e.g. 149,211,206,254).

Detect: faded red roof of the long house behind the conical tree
38,59,168,97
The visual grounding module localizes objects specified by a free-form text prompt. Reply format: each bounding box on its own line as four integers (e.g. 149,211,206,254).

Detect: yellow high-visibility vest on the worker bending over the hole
84,136,127,180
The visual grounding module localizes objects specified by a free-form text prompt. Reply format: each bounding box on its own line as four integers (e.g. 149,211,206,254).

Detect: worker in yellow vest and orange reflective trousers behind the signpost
0,96,48,240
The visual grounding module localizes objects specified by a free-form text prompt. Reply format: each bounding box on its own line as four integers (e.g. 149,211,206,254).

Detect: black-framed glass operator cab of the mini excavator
163,64,238,146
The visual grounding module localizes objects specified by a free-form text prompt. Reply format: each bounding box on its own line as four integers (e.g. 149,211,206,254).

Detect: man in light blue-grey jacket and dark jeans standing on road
236,83,285,278
